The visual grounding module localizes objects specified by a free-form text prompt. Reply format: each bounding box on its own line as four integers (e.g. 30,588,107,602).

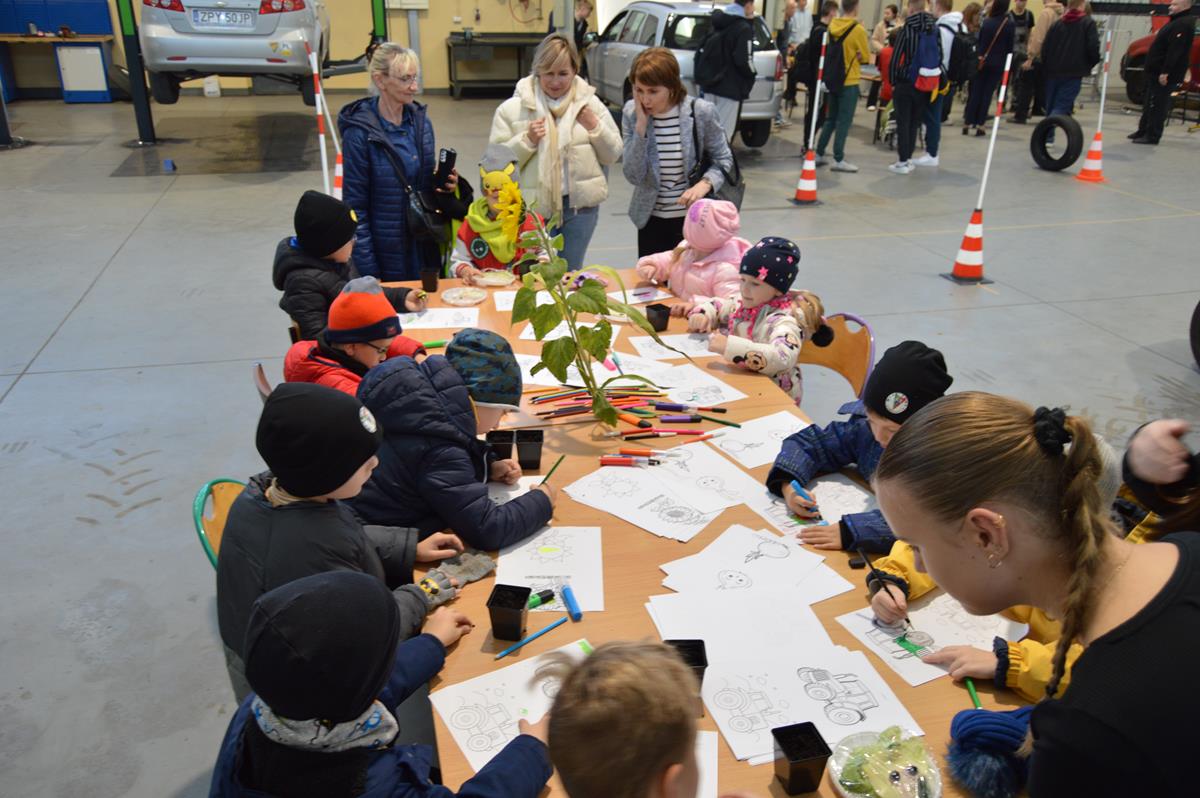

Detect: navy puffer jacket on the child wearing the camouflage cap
352,355,553,551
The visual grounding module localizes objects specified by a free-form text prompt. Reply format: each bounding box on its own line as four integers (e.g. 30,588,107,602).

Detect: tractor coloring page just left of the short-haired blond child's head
430,640,592,770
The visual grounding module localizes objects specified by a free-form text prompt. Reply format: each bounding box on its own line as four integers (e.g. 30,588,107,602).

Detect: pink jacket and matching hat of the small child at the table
637,199,751,302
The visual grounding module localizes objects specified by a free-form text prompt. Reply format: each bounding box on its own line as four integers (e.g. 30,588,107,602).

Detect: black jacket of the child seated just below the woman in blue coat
271,236,409,341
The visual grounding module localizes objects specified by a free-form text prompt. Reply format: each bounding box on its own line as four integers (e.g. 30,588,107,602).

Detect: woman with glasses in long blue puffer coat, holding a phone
337,42,470,281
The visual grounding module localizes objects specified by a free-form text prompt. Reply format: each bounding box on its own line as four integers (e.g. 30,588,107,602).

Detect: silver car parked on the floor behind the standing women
586,0,785,146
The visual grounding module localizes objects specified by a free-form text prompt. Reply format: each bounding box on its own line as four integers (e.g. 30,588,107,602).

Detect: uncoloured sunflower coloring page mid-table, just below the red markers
564,466,718,542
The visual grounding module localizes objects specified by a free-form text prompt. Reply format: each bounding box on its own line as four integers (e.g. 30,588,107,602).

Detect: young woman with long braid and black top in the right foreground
875,392,1200,798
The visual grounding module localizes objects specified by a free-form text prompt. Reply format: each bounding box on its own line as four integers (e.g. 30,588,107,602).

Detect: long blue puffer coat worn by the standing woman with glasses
337,97,440,281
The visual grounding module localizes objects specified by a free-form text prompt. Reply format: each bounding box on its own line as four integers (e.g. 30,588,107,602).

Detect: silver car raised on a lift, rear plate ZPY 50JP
139,0,330,106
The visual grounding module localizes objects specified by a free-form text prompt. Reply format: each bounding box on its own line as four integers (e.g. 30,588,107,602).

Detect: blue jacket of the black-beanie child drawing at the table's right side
767,402,896,553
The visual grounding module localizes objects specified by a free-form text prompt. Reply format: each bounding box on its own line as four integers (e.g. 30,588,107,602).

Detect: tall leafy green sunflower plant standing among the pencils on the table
502,209,682,426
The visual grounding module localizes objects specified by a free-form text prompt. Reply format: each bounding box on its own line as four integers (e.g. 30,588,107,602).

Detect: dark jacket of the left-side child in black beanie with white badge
217,472,428,658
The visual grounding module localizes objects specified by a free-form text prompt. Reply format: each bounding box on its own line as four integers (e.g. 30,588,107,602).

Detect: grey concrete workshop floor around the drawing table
0,90,1200,798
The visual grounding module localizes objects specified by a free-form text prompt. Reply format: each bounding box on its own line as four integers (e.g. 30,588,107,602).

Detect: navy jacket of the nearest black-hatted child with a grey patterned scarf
209,635,551,798
